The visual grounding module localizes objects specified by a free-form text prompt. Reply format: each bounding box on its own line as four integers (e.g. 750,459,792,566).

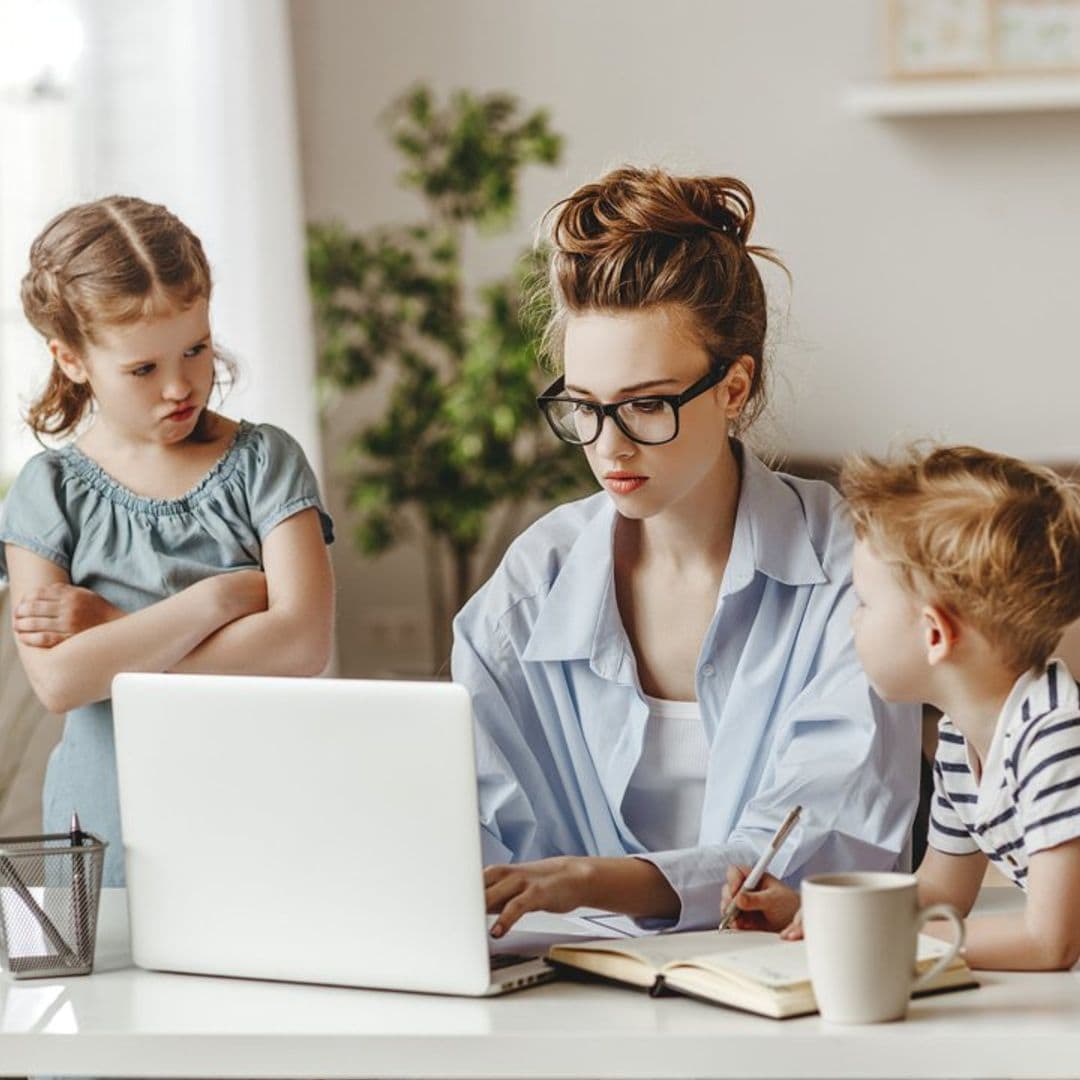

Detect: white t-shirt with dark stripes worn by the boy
929,660,1080,888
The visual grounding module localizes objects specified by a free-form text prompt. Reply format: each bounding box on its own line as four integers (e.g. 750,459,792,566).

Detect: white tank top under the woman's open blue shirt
622,694,708,851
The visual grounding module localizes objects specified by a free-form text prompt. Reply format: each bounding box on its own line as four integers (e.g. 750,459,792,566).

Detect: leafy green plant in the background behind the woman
308,86,588,671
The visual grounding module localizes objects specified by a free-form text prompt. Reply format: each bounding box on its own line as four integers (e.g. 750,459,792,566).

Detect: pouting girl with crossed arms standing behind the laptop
0,197,333,886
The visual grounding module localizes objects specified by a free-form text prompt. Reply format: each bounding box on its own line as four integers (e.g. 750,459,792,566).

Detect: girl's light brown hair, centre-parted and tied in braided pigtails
22,195,233,435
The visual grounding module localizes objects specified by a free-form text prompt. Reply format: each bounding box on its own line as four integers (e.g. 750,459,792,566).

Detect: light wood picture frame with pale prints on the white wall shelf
889,0,1080,79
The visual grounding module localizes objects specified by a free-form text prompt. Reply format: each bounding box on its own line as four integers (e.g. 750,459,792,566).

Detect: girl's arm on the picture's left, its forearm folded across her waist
4,543,266,713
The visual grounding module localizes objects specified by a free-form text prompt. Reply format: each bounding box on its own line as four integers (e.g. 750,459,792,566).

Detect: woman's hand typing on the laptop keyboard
484,855,595,937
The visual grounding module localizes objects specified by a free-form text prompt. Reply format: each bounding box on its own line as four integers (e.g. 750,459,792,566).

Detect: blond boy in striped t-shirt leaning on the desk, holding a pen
725,446,1080,971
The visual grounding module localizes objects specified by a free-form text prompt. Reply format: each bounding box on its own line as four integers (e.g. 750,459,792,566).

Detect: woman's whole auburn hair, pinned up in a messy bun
543,166,786,430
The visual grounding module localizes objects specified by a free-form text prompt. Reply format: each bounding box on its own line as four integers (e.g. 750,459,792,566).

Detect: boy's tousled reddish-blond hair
840,446,1080,672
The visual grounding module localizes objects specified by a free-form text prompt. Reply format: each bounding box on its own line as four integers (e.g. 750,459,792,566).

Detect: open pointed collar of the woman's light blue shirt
522,442,828,665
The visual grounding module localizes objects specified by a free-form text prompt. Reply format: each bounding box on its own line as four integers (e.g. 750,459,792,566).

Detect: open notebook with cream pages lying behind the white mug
548,930,978,1020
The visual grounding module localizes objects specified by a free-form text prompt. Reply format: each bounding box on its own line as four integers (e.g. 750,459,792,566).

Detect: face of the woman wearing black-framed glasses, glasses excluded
564,308,752,518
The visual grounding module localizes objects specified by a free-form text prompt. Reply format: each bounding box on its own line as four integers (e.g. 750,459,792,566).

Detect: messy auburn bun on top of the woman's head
552,166,754,254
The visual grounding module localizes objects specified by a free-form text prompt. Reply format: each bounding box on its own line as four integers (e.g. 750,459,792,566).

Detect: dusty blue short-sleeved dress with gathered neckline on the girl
0,421,334,886
